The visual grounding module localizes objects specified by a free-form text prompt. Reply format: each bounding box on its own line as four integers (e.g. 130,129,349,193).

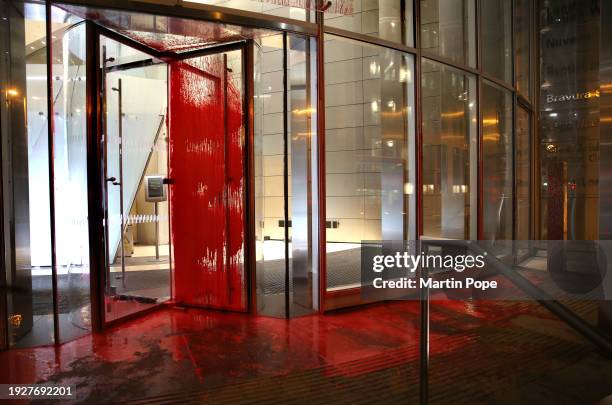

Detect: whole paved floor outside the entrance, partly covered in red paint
0,300,612,404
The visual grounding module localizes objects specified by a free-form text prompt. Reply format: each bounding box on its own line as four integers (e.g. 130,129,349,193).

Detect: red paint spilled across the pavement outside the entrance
0,301,548,401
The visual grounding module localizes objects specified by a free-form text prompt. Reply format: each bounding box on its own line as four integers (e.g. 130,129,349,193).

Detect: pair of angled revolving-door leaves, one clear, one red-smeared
98,33,248,323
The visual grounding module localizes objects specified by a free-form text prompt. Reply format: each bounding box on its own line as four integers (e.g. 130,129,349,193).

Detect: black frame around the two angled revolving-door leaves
86,20,256,332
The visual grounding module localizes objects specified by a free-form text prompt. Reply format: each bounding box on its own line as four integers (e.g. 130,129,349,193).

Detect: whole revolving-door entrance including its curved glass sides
0,1,320,350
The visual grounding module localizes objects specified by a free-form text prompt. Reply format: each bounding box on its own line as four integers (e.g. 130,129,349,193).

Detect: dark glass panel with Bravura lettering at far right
537,0,596,240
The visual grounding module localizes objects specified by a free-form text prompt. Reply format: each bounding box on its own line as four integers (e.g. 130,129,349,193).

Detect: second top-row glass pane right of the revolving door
420,0,476,67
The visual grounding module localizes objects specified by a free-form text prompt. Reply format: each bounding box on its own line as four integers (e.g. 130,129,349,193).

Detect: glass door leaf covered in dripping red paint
169,50,247,311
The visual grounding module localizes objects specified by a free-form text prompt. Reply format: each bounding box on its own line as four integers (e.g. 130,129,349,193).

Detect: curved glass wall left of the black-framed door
0,1,91,347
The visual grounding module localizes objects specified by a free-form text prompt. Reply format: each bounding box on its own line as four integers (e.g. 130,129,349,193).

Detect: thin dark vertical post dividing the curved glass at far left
45,0,60,344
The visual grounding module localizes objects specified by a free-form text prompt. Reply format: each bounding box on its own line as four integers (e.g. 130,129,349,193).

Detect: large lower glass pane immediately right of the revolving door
325,36,415,291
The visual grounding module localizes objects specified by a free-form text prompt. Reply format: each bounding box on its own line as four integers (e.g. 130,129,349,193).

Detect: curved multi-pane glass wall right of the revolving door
324,0,533,309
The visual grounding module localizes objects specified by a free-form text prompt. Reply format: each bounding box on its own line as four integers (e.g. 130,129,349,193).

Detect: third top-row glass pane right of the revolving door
480,0,512,83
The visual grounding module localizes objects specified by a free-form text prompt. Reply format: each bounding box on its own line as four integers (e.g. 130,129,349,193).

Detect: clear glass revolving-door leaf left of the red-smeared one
100,37,171,322
